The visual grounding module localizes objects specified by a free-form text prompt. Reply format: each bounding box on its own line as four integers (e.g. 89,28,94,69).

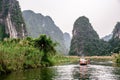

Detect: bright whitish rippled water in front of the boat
54,65,120,80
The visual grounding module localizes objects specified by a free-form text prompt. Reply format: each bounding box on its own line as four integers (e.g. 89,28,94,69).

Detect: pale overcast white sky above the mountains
18,0,120,37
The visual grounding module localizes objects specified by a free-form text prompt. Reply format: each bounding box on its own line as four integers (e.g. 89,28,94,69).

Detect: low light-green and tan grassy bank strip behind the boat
56,56,114,65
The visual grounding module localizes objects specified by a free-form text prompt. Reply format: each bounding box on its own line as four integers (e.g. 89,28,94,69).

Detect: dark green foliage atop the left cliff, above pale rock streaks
0,0,24,29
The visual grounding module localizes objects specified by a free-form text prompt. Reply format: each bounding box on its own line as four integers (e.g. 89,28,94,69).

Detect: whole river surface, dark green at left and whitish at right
0,61,120,80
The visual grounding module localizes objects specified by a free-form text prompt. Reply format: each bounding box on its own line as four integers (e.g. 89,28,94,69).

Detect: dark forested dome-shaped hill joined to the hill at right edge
69,19,120,56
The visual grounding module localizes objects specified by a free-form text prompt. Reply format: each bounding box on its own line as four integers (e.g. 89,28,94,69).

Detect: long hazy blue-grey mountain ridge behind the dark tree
23,10,67,54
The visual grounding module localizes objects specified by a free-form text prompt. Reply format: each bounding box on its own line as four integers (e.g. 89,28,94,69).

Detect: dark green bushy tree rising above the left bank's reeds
34,35,57,65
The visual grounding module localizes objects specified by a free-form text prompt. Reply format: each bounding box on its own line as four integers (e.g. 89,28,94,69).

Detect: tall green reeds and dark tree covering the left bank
0,35,70,74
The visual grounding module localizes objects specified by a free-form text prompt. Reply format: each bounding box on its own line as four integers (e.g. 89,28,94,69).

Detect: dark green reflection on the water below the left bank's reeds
0,68,55,80
